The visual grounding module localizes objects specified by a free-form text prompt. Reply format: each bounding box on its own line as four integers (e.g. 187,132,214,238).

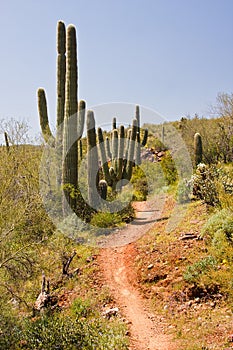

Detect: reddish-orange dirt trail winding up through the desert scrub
99,197,176,350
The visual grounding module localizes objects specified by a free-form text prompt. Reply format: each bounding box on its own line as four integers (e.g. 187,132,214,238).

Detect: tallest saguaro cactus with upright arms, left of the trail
38,21,85,213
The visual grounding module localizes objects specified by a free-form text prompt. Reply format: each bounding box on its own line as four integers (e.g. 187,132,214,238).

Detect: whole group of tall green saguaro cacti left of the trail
37,21,148,214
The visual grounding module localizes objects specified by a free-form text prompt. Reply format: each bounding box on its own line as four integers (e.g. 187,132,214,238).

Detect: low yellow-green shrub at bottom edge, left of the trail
19,301,127,350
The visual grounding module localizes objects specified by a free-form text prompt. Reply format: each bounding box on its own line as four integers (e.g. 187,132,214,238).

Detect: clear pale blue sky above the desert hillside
0,0,233,137
